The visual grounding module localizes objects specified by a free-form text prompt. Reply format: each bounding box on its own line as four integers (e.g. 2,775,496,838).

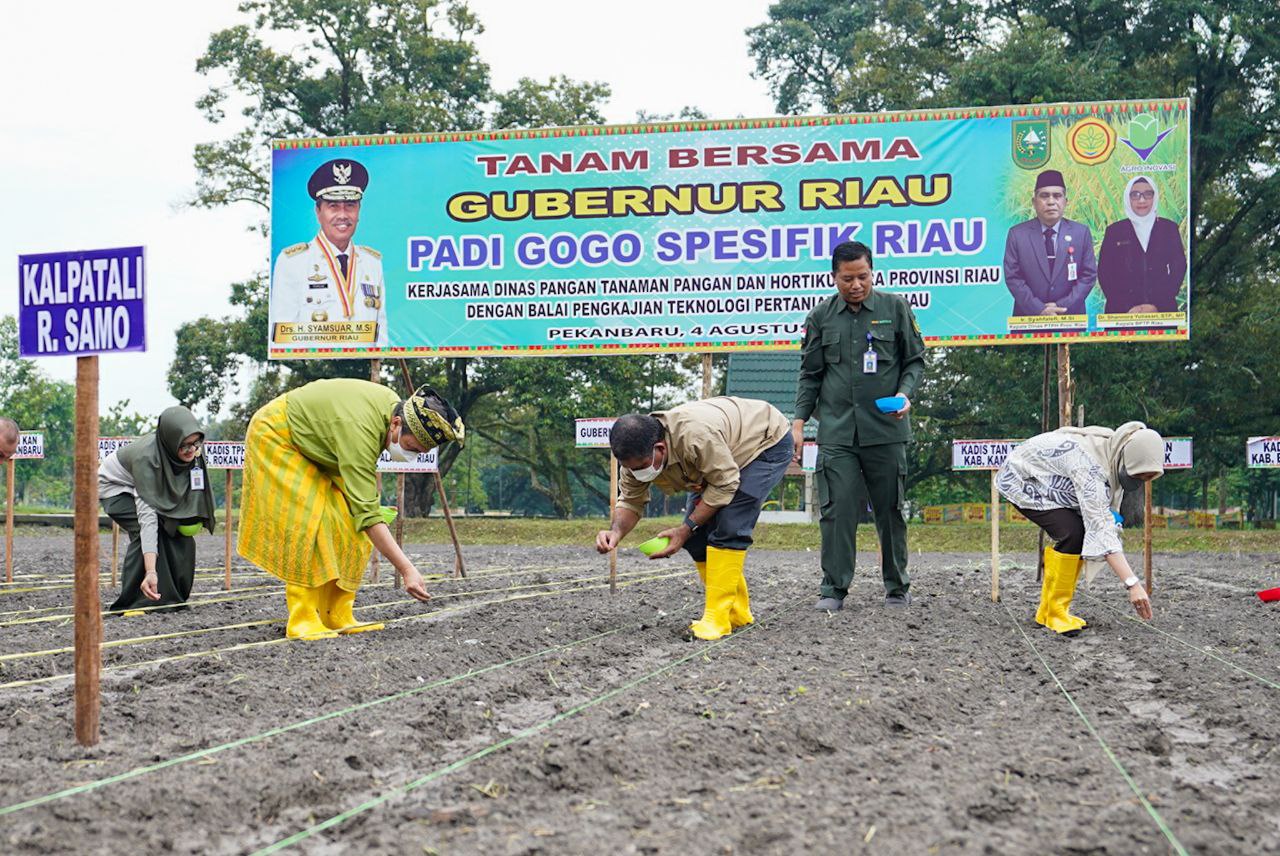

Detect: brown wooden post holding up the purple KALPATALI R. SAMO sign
74,357,102,746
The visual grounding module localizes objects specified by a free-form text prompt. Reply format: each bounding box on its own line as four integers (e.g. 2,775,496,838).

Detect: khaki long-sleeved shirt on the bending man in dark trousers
617,395,790,516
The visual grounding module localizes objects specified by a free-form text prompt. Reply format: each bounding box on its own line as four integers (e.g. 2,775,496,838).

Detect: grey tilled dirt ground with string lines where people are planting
0,536,1280,856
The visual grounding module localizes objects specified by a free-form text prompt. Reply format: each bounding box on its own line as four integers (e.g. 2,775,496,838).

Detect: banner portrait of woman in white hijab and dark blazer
1098,175,1187,315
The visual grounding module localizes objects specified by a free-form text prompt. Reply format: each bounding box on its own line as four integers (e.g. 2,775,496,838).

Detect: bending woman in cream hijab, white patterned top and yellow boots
996,422,1165,636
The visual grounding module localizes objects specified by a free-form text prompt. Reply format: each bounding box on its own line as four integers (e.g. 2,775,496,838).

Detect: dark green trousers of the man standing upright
814,443,911,599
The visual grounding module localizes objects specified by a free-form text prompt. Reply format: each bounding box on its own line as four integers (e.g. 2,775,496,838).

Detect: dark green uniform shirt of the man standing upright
795,292,924,447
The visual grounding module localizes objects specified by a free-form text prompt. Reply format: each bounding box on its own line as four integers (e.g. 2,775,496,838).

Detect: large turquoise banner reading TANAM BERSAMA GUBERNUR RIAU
268,99,1190,358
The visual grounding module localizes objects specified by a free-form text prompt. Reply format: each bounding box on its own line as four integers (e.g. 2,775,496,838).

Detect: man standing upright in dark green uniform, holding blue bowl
791,242,924,612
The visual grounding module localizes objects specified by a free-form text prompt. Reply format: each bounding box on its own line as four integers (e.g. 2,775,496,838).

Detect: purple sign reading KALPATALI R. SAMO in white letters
18,247,147,357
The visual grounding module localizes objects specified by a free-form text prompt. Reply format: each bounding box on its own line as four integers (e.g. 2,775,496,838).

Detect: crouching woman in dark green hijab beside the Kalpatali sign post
97,406,214,610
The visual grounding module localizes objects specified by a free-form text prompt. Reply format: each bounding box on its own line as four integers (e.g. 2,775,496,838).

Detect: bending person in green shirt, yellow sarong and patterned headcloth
238,379,463,640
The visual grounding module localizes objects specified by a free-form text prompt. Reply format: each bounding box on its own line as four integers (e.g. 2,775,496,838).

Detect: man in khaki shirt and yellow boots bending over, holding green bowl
595,395,792,640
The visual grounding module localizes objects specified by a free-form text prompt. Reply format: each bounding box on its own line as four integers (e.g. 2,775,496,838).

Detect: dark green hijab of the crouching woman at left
115,404,214,535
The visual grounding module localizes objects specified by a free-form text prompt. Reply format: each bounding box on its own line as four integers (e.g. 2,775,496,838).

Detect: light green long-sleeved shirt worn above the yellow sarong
284,377,399,532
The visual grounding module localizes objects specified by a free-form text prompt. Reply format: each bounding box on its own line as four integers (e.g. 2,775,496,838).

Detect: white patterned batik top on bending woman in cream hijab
996,431,1124,559
